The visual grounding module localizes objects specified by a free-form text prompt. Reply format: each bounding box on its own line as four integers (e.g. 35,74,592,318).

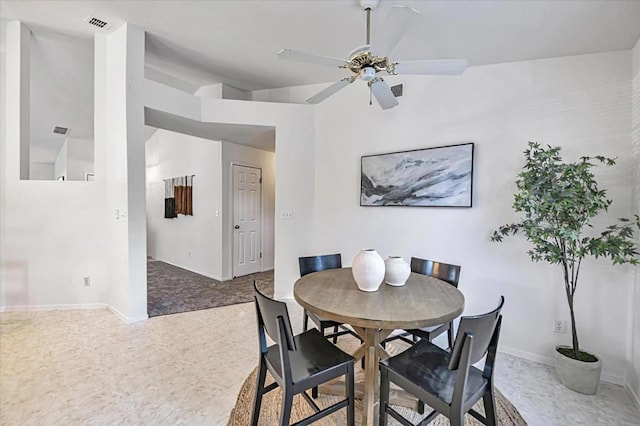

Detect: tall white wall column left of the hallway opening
95,24,147,322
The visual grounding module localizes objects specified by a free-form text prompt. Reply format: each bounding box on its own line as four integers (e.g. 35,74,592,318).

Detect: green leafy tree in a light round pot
491,142,640,394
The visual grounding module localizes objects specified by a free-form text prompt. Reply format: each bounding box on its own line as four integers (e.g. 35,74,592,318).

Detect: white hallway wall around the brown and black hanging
146,129,222,280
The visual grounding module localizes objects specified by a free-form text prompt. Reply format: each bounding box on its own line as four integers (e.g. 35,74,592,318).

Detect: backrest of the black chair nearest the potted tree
449,296,504,370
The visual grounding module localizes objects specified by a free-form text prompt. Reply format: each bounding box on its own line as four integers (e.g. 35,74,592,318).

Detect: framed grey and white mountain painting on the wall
360,143,473,207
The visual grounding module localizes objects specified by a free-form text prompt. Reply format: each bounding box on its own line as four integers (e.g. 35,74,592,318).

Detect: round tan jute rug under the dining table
228,339,527,426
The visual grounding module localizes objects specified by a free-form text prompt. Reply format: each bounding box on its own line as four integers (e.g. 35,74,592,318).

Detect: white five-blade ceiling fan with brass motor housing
278,0,467,109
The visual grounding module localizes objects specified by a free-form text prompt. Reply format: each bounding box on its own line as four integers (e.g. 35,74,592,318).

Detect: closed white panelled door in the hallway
233,165,262,277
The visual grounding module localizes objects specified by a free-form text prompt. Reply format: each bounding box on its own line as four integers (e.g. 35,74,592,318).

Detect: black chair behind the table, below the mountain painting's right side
384,257,461,348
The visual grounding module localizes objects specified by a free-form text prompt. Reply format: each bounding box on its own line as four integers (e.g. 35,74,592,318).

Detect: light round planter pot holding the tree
555,346,602,395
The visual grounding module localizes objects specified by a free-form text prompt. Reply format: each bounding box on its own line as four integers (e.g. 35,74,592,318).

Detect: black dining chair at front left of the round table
251,281,355,426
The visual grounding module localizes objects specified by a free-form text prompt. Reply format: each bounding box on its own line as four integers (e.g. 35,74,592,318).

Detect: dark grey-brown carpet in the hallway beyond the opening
147,260,273,317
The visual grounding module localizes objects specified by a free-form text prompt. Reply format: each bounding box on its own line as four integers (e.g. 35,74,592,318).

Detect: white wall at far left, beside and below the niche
0,22,107,309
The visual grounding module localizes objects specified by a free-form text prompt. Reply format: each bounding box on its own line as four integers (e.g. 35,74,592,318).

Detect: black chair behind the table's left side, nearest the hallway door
298,253,362,343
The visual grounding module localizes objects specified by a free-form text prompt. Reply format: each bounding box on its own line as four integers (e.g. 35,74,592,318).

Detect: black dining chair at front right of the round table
380,296,504,426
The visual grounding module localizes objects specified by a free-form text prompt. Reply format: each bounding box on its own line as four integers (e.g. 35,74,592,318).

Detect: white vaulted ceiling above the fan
0,0,640,164
